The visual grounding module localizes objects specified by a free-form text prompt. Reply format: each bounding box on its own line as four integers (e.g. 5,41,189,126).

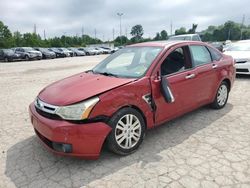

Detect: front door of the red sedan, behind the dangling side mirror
151,46,195,125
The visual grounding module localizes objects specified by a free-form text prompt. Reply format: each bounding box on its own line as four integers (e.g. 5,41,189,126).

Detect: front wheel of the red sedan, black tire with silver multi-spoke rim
107,108,146,155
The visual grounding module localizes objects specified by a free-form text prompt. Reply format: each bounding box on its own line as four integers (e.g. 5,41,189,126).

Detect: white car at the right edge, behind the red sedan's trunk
224,41,250,75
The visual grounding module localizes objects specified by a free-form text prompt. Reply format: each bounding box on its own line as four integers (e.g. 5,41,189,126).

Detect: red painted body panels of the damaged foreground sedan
30,41,235,159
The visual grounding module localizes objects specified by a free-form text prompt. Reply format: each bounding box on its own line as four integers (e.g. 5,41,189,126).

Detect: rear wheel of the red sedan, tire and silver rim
211,81,229,109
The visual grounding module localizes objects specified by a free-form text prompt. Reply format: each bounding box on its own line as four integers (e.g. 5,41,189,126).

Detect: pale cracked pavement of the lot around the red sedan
0,55,250,188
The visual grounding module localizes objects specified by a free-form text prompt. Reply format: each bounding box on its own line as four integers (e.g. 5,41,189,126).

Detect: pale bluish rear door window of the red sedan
189,45,212,66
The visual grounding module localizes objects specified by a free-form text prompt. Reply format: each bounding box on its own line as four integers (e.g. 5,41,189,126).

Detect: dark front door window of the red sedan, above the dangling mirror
161,48,189,76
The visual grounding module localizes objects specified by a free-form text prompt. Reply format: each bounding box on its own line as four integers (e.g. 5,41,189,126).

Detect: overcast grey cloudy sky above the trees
0,0,250,41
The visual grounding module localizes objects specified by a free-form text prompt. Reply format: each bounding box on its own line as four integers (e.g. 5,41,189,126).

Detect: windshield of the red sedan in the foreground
93,47,163,78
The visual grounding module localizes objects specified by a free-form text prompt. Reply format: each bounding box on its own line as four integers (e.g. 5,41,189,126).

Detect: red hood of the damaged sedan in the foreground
38,72,135,106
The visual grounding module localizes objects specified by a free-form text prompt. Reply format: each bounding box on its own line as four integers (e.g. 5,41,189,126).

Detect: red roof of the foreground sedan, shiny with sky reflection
129,40,206,48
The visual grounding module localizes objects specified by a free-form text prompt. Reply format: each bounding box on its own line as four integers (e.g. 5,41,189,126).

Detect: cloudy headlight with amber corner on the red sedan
55,97,99,120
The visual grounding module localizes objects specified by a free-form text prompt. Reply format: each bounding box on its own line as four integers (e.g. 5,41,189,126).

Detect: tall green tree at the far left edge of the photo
0,21,14,48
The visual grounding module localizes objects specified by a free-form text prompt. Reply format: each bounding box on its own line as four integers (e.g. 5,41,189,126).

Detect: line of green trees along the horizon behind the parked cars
0,21,250,48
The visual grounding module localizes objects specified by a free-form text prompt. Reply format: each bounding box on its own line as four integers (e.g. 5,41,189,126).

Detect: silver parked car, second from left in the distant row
14,47,42,60
